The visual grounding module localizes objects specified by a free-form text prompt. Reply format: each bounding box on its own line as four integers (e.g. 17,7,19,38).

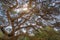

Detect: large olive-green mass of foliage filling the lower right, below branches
16,27,60,40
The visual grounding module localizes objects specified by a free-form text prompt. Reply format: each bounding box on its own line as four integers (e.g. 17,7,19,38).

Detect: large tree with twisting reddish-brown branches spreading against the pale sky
0,0,60,40
